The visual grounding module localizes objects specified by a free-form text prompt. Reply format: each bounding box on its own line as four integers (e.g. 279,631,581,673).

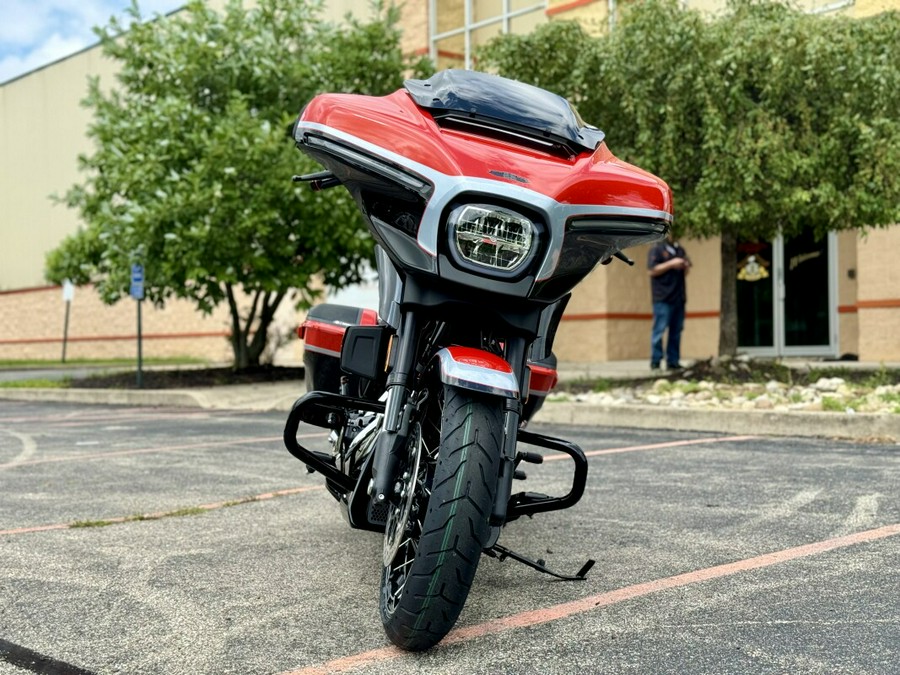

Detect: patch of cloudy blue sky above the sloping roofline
0,0,185,82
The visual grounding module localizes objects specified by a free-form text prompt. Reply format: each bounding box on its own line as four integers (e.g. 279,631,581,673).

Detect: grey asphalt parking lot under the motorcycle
0,401,900,675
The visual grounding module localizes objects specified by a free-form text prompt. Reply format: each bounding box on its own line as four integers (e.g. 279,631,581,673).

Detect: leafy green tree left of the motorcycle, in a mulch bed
46,0,432,368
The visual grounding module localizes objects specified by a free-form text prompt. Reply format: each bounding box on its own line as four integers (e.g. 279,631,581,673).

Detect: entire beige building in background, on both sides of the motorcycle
0,0,900,362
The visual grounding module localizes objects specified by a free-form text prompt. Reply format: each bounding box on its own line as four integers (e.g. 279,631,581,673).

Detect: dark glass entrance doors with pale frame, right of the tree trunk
737,233,838,356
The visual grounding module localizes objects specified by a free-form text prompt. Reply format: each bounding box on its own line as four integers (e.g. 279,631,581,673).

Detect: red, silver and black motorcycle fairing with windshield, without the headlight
294,71,672,302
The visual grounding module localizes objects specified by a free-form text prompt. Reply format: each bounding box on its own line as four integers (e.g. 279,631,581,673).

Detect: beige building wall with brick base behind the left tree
0,0,400,362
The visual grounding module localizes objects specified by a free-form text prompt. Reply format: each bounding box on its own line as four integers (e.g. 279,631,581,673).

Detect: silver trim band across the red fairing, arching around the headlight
294,120,673,281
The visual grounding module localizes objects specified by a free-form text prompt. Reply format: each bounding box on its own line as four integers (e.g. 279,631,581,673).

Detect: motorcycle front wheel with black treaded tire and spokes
380,386,503,651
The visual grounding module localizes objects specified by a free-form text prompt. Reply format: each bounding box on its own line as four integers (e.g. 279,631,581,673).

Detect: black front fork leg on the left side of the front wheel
369,312,419,504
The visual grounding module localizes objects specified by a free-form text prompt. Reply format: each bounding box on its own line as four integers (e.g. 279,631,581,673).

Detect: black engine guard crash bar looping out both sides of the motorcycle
284,391,588,522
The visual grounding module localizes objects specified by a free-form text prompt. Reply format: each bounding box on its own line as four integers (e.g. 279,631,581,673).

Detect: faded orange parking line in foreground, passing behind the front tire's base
282,523,900,675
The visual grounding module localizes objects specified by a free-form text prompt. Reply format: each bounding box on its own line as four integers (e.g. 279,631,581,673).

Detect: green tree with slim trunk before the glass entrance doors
481,0,900,354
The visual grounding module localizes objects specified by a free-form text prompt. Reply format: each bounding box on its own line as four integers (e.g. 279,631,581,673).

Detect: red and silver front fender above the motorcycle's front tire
436,346,519,398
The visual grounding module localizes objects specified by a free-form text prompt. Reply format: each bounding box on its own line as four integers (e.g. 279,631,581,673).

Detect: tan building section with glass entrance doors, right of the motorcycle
427,0,900,362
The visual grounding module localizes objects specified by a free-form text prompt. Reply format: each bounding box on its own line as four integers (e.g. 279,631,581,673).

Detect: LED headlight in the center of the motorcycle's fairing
448,204,536,272
